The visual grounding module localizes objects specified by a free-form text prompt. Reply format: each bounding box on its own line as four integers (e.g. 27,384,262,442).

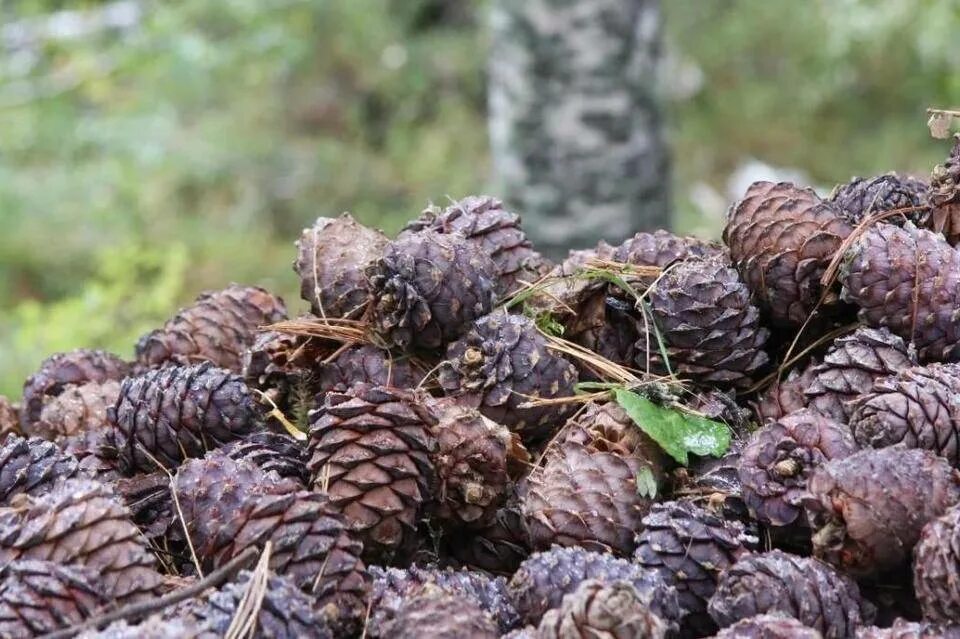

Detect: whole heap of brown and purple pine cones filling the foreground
0,134,960,639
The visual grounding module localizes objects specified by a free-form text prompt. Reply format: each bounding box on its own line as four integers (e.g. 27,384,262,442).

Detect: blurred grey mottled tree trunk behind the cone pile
489,0,670,256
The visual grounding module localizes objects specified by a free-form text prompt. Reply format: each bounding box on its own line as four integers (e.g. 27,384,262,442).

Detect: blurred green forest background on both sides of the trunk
0,0,960,398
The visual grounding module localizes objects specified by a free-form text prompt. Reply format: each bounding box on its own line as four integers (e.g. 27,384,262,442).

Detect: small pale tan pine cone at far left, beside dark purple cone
27,379,120,439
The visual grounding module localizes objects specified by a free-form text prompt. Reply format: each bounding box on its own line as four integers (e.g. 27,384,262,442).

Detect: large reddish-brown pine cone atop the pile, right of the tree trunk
723,182,852,326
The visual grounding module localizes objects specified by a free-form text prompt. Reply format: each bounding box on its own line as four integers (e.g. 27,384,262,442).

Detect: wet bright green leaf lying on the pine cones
613,388,730,465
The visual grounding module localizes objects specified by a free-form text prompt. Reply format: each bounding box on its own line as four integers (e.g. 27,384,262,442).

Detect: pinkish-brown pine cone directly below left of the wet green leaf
520,428,662,555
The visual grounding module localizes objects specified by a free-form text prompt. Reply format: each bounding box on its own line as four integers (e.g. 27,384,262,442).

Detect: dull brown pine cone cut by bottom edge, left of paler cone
382,588,500,639
